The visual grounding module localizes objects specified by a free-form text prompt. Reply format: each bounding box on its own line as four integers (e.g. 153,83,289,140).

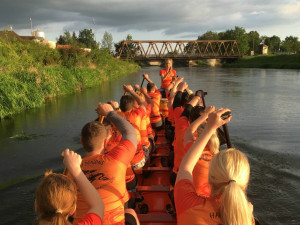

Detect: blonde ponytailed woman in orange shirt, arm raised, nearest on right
174,108,254,225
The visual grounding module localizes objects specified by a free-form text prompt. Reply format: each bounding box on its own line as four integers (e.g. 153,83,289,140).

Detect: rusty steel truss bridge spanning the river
116,40,241,60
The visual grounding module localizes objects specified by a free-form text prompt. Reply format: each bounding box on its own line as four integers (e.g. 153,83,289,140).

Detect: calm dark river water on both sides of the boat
0,67,300,224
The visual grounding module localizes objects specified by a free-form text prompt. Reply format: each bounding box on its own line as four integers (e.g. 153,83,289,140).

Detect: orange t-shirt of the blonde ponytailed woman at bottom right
174,179,222,225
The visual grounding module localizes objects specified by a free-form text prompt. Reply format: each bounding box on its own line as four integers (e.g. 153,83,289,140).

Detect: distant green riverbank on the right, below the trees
222,54,300,69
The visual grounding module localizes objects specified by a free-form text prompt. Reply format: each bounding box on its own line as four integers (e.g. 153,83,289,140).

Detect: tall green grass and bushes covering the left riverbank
0,39,140,119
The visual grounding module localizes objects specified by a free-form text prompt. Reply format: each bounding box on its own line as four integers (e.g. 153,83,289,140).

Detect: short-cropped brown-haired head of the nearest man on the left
81,121,110,152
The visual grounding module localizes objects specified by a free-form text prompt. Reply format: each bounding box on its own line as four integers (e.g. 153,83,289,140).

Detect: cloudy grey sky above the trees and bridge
0,0,300,43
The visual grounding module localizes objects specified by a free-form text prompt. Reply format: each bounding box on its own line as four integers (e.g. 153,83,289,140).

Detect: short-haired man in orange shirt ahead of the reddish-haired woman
67,104,137,224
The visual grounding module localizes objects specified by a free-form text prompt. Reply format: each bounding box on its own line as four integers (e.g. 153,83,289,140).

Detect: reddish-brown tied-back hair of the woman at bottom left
35,171,77,225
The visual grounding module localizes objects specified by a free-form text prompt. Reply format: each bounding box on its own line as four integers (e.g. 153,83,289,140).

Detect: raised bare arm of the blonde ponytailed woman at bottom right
176,108,231,183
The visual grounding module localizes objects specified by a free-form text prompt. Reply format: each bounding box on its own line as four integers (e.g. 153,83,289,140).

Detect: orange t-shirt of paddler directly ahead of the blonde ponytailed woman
184,142,214,197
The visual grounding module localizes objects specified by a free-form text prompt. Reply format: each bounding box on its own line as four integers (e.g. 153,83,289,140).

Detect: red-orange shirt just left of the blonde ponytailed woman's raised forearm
173,115,190,173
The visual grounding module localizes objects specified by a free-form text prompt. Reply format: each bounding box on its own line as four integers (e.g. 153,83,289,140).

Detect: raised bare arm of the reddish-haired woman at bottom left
64,149,104,219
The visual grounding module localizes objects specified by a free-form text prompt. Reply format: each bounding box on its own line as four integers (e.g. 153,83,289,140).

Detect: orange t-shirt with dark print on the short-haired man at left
67,140,135,225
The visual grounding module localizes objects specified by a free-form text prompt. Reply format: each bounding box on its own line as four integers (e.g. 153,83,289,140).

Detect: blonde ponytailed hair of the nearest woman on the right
208,148,254,225
